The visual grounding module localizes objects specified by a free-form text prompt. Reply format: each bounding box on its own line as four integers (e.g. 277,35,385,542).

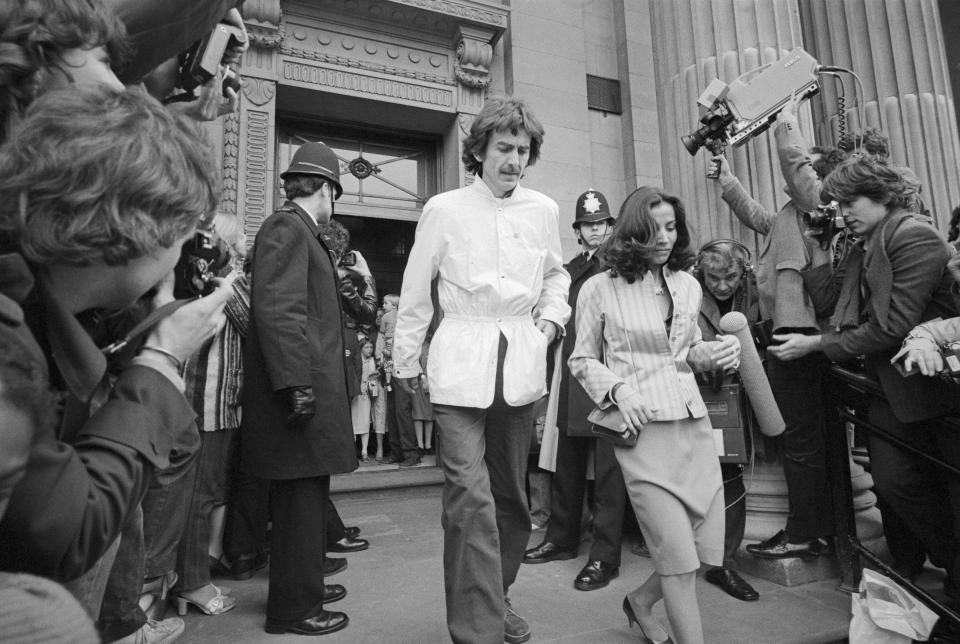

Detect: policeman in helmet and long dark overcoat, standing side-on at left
241,143,357,635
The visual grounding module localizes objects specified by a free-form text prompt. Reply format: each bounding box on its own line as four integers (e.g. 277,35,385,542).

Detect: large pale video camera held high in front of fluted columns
680,47,820,176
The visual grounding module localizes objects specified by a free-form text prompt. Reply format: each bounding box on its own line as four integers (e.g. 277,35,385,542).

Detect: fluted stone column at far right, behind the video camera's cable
799,0,960,231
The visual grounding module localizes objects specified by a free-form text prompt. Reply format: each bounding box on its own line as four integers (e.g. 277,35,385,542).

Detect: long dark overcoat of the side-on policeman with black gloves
241,202,357,479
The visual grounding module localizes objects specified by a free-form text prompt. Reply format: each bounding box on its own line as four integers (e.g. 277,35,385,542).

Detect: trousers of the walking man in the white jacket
434,335,534,644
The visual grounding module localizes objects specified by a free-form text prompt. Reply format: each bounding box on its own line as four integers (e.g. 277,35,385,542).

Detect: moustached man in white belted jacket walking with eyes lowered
394,97,570,644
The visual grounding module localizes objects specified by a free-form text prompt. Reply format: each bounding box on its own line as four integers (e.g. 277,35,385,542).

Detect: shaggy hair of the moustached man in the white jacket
461,96,543,176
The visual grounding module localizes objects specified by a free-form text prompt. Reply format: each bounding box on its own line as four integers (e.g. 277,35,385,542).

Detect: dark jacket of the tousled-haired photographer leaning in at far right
803,213,957,422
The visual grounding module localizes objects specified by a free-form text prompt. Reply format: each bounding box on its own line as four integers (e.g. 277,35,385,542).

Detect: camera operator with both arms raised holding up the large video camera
714,95,841,559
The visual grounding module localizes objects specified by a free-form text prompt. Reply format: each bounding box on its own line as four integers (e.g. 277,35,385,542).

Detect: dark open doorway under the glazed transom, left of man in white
335,215,417,302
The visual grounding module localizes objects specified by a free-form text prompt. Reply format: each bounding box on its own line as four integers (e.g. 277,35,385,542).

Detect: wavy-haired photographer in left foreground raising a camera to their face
0,87,231,592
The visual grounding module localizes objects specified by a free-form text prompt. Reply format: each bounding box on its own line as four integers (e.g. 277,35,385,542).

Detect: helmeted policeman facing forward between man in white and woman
523,189,626,590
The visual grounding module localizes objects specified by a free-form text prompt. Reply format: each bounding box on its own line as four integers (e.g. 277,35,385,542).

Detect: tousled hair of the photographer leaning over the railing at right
820,156,918,210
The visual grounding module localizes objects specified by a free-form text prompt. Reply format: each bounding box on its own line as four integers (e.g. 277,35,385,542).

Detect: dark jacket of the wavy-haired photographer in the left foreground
0,254,196,582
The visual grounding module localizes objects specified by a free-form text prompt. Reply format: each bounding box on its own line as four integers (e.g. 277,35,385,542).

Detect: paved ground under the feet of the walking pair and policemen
174,485,864,644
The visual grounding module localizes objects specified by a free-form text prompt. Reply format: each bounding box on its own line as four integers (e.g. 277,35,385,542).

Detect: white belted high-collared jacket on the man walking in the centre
393,177,570,408
